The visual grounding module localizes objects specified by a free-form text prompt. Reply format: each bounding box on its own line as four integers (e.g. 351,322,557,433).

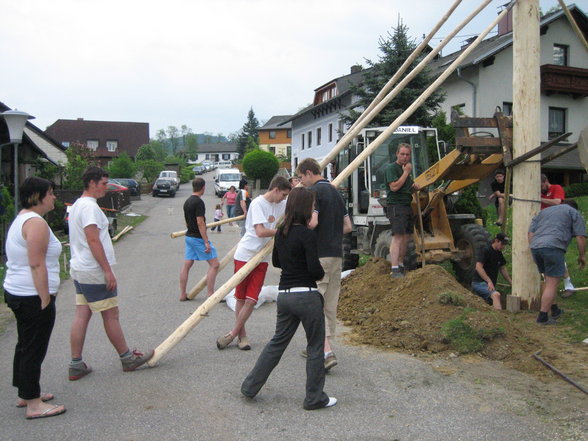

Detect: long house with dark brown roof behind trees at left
45,118,149,166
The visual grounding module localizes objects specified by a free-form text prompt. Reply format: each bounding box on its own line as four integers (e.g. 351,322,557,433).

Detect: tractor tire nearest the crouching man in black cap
453,224,490,289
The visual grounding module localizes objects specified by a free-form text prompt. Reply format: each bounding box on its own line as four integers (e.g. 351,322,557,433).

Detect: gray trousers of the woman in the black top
241,290,329,410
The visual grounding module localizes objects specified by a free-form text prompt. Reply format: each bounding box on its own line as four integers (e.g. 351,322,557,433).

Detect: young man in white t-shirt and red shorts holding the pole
216,176,291,351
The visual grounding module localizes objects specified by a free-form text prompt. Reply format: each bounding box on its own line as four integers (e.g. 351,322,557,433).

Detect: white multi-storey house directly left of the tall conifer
288,66,365,170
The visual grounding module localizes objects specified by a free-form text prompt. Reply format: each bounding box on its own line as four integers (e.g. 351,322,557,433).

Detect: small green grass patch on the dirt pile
441,313,504,354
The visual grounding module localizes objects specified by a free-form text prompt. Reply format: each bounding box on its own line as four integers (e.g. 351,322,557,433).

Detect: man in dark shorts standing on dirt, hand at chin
386,143,419,278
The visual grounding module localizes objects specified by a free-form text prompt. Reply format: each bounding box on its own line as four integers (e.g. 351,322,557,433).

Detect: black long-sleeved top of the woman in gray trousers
272,225,325,289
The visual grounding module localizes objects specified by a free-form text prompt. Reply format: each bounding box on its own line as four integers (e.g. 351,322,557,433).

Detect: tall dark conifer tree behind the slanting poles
342,22,445,127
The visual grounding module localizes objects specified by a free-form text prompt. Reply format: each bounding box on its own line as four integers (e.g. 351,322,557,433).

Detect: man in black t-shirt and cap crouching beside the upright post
472,233,512,309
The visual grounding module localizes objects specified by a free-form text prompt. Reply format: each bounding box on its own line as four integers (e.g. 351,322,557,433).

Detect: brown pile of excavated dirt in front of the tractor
338,258,588,379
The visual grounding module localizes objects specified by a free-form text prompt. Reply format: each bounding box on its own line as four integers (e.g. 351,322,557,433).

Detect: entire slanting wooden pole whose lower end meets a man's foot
148,3,512,366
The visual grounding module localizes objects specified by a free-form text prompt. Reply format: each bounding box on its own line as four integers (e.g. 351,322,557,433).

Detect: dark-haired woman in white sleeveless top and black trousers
4,177,65,419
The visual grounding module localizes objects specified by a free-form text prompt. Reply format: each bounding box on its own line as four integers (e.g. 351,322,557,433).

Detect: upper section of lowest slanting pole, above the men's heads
333,3,513,186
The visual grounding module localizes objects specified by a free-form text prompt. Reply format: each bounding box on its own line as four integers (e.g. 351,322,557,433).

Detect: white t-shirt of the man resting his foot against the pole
69,197,116,271
